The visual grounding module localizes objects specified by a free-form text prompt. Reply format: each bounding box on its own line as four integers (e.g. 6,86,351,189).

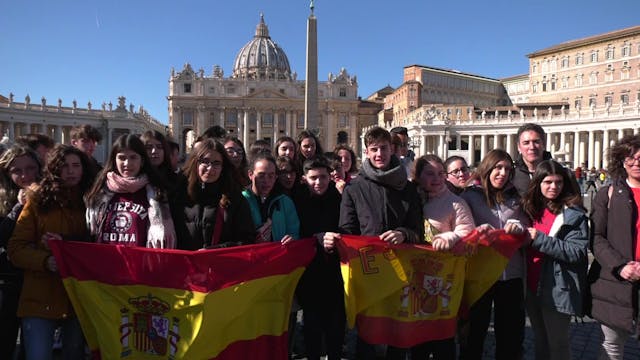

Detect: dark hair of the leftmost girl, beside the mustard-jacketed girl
0,145,42,216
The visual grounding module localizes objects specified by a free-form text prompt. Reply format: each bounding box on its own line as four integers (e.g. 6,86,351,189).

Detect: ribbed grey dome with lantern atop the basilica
231,14,291,79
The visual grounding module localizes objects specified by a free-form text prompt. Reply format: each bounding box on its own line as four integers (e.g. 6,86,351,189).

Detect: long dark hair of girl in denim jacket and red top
522,160,582,221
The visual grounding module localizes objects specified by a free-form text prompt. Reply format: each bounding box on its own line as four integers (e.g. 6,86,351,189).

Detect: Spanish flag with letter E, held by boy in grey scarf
338,230,522,348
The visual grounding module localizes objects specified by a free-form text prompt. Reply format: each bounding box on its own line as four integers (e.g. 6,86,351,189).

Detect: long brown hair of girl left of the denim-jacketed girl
476,149,517,207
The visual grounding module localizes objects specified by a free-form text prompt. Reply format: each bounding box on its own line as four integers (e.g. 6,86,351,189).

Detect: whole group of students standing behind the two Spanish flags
0,124,640,359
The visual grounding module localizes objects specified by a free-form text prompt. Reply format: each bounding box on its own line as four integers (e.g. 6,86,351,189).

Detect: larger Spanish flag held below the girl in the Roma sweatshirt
50,239,315,359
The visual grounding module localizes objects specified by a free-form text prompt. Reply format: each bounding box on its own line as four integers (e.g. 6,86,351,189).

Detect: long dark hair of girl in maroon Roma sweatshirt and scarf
87,134,167,201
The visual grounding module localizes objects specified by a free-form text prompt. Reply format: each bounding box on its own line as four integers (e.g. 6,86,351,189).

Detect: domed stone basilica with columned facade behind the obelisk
168,15,359,152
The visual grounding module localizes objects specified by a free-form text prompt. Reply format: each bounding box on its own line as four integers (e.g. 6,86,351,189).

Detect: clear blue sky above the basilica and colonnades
0,0,640,123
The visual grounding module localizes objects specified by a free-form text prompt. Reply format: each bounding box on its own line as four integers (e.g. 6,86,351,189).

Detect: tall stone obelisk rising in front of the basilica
304,0,320,134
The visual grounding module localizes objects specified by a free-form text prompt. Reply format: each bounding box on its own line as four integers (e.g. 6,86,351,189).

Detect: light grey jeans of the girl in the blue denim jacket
526,292,571,360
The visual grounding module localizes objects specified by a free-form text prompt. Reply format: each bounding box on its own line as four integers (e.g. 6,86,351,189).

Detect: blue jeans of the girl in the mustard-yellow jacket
22,317,84,360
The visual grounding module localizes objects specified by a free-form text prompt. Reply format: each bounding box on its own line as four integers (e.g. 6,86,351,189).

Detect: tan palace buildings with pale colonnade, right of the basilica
376,26,640,169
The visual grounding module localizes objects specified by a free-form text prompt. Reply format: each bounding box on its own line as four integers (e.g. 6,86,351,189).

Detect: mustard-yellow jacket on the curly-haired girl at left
7,200,88,319
